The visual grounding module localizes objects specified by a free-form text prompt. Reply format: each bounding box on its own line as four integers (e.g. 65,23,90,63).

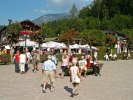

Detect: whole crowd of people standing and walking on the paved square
14,49,101,97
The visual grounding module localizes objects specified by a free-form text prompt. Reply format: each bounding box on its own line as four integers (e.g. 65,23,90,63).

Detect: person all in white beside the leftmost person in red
19,52,26,74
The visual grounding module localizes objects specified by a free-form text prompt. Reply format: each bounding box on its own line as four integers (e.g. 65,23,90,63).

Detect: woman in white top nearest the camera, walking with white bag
70,60,81,97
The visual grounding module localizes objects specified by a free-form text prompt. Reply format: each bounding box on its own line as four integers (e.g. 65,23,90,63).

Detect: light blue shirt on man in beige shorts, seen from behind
42,60,56,71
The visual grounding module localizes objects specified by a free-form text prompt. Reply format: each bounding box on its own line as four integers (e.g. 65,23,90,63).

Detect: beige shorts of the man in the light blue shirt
43,71,55,82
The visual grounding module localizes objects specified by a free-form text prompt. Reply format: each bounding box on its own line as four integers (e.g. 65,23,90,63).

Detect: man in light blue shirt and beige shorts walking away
42,55,56,93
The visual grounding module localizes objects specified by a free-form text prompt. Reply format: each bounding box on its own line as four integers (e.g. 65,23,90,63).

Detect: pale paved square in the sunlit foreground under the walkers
0,60,133,100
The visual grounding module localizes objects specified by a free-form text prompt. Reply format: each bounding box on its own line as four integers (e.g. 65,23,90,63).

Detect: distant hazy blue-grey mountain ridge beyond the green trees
33,13,69,25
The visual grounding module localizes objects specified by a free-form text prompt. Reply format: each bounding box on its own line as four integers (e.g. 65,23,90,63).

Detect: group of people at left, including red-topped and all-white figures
13,49,40,74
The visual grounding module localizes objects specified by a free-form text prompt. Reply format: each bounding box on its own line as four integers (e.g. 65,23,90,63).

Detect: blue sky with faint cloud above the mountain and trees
0,0,93,25
